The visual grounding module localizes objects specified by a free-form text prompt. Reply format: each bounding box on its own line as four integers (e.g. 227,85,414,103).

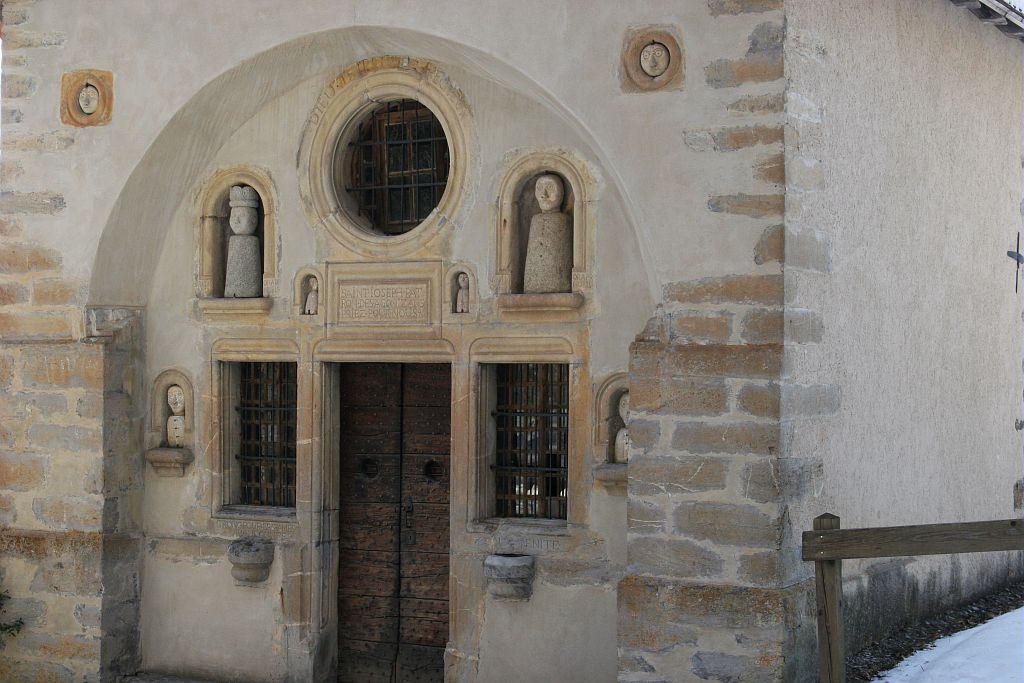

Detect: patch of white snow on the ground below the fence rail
874,607,1024,683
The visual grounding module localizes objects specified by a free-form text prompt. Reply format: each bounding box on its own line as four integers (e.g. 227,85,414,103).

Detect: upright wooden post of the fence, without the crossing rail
814,513,846,683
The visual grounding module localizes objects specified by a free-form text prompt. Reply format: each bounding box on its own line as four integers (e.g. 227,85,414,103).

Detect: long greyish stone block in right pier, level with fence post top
673,501,782,548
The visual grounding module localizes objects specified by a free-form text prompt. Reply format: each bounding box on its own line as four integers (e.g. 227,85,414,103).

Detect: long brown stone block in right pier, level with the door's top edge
668,344,782,379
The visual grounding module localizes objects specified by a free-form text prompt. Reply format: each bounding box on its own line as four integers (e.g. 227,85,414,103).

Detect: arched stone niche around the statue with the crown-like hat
196,166,278,301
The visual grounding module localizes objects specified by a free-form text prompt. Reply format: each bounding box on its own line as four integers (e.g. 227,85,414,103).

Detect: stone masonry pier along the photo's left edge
0,0,141,683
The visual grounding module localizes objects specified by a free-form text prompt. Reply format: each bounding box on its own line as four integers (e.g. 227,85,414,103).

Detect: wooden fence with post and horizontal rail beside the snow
803,513,1024,683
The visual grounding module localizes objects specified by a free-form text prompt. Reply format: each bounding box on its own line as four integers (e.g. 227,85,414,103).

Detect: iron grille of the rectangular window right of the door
493,362,569,519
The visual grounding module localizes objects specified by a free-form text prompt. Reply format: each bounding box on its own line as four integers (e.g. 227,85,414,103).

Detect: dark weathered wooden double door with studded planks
338,364,452,683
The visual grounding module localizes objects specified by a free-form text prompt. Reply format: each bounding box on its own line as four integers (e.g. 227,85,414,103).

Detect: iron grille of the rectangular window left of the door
236,362,297,507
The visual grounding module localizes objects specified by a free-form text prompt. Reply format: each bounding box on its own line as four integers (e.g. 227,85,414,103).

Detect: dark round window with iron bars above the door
335,99,451,236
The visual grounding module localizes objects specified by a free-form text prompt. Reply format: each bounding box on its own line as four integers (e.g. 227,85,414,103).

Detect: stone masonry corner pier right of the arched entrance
618,0,816,681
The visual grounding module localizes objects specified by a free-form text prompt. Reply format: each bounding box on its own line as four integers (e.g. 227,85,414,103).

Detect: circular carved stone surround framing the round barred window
298,57,471,258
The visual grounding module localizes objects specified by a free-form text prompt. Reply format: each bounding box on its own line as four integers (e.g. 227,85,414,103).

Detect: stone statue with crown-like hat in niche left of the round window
224,185,263,299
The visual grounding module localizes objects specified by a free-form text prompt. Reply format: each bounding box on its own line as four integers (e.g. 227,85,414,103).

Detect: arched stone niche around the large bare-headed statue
495,150,593,295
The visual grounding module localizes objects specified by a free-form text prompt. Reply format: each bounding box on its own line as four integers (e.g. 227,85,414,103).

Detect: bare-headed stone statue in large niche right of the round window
522,173,572,293
